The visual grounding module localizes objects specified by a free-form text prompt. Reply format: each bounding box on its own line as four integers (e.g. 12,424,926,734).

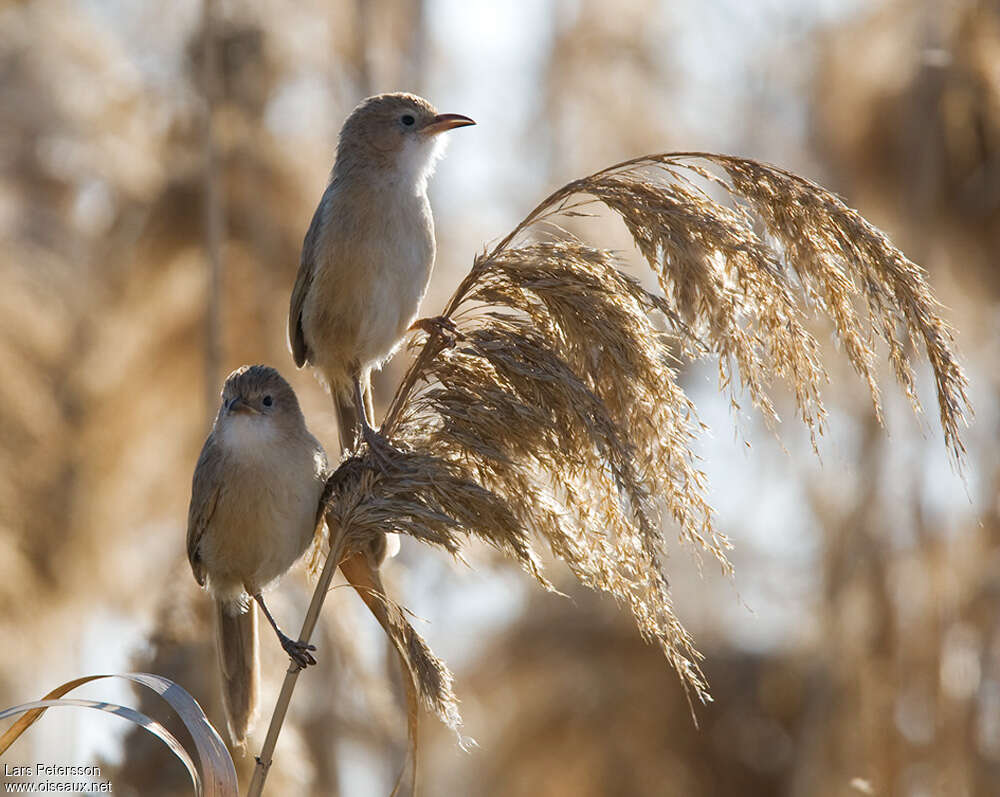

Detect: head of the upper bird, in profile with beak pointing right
334,93,475,193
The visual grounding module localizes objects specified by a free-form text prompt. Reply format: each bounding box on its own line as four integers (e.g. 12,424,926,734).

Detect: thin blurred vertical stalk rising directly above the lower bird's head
201,0,225,425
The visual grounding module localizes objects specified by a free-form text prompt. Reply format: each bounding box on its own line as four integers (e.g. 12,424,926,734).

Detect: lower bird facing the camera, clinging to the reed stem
187,365,327,747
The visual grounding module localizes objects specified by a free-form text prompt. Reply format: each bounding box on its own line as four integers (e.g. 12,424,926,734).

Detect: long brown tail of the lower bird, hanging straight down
215,601,260,748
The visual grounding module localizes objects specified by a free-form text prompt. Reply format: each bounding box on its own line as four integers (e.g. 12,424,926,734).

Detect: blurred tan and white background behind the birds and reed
0,0,1000,797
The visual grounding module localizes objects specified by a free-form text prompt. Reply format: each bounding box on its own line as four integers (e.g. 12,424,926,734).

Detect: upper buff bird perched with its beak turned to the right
288,92,475,470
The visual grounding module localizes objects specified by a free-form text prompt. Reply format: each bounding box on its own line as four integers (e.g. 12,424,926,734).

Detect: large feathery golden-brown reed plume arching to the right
327,153,971,728
